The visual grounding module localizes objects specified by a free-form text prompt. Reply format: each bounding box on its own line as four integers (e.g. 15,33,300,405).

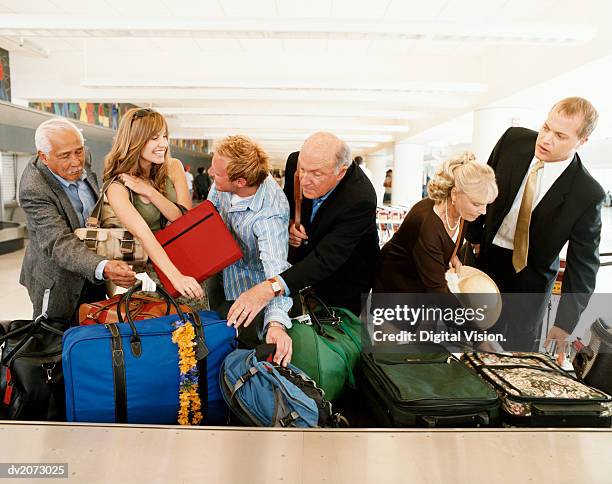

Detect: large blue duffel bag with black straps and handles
62,286,236,424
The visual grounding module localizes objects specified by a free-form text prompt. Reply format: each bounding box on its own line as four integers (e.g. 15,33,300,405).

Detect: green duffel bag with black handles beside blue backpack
289,294,361,400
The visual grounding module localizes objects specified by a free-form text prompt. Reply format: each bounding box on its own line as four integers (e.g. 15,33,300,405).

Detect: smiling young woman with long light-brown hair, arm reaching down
104,109,208,309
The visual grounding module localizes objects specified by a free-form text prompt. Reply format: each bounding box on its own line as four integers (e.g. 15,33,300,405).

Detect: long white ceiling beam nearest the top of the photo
0,14,596,45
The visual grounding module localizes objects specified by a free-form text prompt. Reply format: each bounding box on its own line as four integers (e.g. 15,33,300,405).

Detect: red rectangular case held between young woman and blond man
154,200,242,297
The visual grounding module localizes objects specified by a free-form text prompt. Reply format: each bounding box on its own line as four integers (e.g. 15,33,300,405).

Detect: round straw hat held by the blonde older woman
446,266,502,331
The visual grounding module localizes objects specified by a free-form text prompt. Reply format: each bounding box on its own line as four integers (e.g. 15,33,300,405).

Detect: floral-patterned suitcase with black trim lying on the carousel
462,353,612,427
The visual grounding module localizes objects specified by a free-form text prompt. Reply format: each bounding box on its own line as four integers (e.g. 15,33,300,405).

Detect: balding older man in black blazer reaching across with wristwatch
228,133,379,325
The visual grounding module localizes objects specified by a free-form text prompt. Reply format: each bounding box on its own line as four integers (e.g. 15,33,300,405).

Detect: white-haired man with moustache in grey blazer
19,118,136,320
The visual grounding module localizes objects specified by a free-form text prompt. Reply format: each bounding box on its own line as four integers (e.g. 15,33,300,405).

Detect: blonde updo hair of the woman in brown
427,151,497,203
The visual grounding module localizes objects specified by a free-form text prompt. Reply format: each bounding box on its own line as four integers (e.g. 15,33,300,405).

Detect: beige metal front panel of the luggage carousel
0,421,612,484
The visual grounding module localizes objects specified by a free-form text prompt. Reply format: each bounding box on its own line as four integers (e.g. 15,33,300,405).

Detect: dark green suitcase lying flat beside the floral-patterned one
360,347,499,427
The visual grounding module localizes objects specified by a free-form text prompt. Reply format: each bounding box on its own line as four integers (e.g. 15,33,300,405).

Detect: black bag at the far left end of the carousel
0,314,69,421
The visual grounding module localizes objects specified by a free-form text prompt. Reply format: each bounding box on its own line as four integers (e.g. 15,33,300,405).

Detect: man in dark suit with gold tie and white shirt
468,98,604,351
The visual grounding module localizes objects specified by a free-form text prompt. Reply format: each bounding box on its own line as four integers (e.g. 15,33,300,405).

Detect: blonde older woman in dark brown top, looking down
373,152,497,293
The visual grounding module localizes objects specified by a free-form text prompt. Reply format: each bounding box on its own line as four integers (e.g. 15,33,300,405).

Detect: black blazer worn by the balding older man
280,157,379,314
